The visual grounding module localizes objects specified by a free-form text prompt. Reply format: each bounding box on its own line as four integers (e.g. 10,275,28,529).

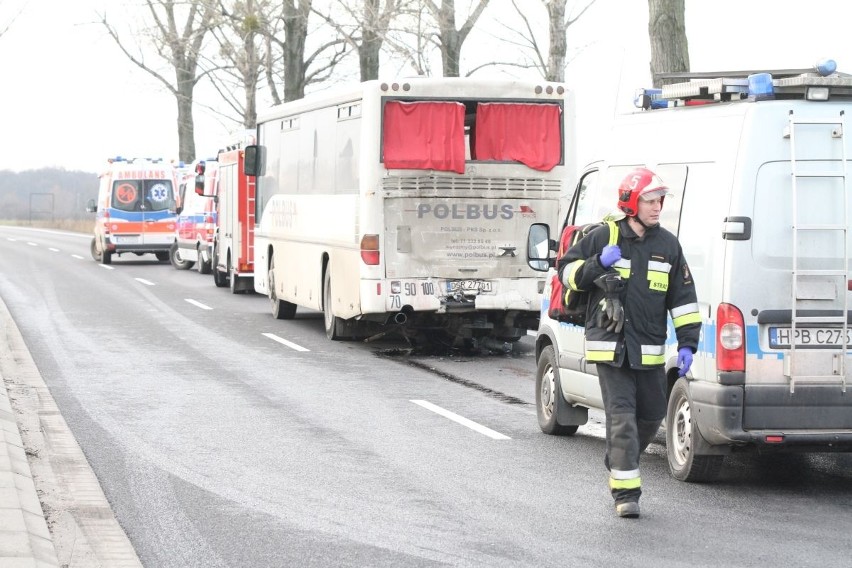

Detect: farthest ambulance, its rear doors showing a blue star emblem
86,157,176,264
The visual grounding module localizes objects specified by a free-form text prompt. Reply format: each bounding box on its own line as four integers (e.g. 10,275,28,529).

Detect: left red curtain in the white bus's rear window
382,101,464,174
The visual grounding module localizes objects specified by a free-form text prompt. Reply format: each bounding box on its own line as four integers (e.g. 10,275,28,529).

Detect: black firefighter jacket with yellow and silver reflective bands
558,219,701,369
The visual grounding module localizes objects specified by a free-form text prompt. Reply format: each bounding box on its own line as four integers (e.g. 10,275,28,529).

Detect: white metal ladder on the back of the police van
784,110,850,394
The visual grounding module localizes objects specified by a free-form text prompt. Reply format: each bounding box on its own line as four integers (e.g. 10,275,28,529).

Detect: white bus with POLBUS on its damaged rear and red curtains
246,78,576,343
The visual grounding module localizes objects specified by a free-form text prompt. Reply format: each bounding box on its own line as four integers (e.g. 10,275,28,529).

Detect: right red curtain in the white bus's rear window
474,103,562,172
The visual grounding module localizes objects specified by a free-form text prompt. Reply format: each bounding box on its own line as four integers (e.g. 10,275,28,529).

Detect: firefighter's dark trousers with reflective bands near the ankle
597,362,666,503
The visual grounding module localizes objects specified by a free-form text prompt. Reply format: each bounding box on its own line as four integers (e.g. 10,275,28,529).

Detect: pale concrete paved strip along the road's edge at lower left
0,298,142,568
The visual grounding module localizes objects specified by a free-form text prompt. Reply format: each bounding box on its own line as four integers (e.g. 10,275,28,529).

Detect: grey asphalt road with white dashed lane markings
0,227,852,567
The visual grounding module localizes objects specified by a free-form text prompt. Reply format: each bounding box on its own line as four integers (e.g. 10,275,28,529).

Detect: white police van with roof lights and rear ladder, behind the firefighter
527,64,852,481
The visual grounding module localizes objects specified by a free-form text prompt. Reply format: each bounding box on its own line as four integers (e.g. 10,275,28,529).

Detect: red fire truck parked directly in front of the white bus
210,147,255,294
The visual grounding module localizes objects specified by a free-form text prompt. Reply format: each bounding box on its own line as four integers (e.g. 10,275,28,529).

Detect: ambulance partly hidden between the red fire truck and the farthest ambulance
170,158,218,274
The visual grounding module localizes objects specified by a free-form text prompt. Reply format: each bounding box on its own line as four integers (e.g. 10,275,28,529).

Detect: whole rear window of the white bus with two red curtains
382,100,563,174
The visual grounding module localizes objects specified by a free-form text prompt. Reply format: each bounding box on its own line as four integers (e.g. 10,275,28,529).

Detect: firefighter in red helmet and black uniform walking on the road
558,168,701,518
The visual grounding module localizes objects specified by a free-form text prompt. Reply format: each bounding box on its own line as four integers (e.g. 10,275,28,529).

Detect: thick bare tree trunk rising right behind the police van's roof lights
648,0,689,87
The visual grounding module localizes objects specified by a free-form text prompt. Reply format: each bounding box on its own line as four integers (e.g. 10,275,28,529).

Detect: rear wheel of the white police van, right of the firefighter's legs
666,378,725,481
